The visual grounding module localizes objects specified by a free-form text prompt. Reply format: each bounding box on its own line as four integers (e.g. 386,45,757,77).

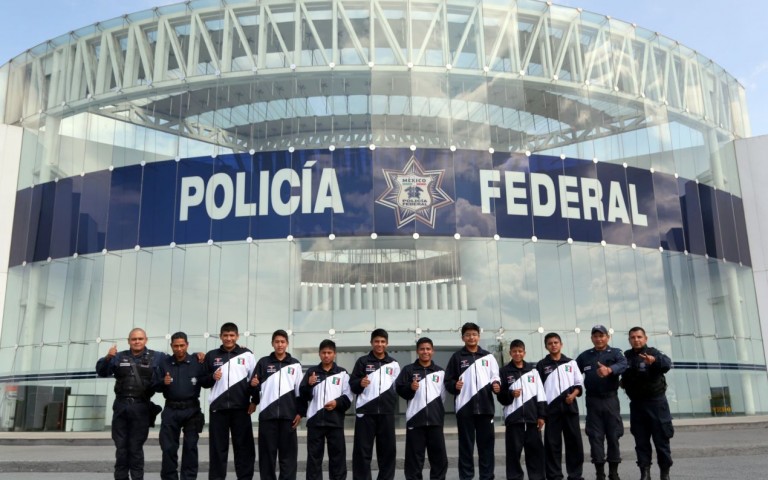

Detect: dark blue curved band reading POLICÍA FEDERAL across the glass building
10,148,751,266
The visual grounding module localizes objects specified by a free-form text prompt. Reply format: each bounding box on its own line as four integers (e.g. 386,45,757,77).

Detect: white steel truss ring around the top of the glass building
0,0,748,150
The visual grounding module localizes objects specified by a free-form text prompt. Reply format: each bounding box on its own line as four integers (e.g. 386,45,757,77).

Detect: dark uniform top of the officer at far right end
621,346,672,400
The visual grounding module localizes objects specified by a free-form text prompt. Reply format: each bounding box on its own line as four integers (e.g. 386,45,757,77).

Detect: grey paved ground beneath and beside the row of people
0,417,768,480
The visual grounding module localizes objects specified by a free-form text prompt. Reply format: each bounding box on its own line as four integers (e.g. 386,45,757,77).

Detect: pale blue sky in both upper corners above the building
0,0,768,136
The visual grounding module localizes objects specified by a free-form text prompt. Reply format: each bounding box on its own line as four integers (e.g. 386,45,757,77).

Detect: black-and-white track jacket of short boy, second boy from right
496,362,547,425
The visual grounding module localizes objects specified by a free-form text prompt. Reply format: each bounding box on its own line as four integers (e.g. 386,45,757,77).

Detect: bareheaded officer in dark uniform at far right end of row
621,327,674,480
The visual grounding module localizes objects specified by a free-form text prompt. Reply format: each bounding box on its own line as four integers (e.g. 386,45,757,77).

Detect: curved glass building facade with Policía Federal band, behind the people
0,0,768,430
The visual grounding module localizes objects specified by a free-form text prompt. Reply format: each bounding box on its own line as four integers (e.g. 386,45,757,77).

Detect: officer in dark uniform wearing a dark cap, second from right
576,325,627,480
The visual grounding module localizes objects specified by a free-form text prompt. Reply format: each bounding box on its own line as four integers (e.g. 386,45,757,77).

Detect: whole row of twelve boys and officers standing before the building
96,323,673,480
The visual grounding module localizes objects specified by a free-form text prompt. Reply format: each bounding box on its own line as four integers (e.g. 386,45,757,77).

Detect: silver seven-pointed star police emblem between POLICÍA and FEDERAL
376,157,453,228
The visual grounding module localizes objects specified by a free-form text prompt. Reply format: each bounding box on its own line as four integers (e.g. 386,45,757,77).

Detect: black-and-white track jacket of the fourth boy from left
349,352,400,415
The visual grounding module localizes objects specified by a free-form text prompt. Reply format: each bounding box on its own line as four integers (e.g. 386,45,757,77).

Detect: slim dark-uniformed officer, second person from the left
156,332,206,480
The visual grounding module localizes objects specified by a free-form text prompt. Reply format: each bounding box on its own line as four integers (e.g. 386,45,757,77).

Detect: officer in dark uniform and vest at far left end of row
96,328,166,480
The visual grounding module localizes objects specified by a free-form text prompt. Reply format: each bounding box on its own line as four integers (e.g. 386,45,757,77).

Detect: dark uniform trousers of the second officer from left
160,402,201,480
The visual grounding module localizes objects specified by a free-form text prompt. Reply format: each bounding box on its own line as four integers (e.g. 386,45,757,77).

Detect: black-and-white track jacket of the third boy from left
299,363,352,428
